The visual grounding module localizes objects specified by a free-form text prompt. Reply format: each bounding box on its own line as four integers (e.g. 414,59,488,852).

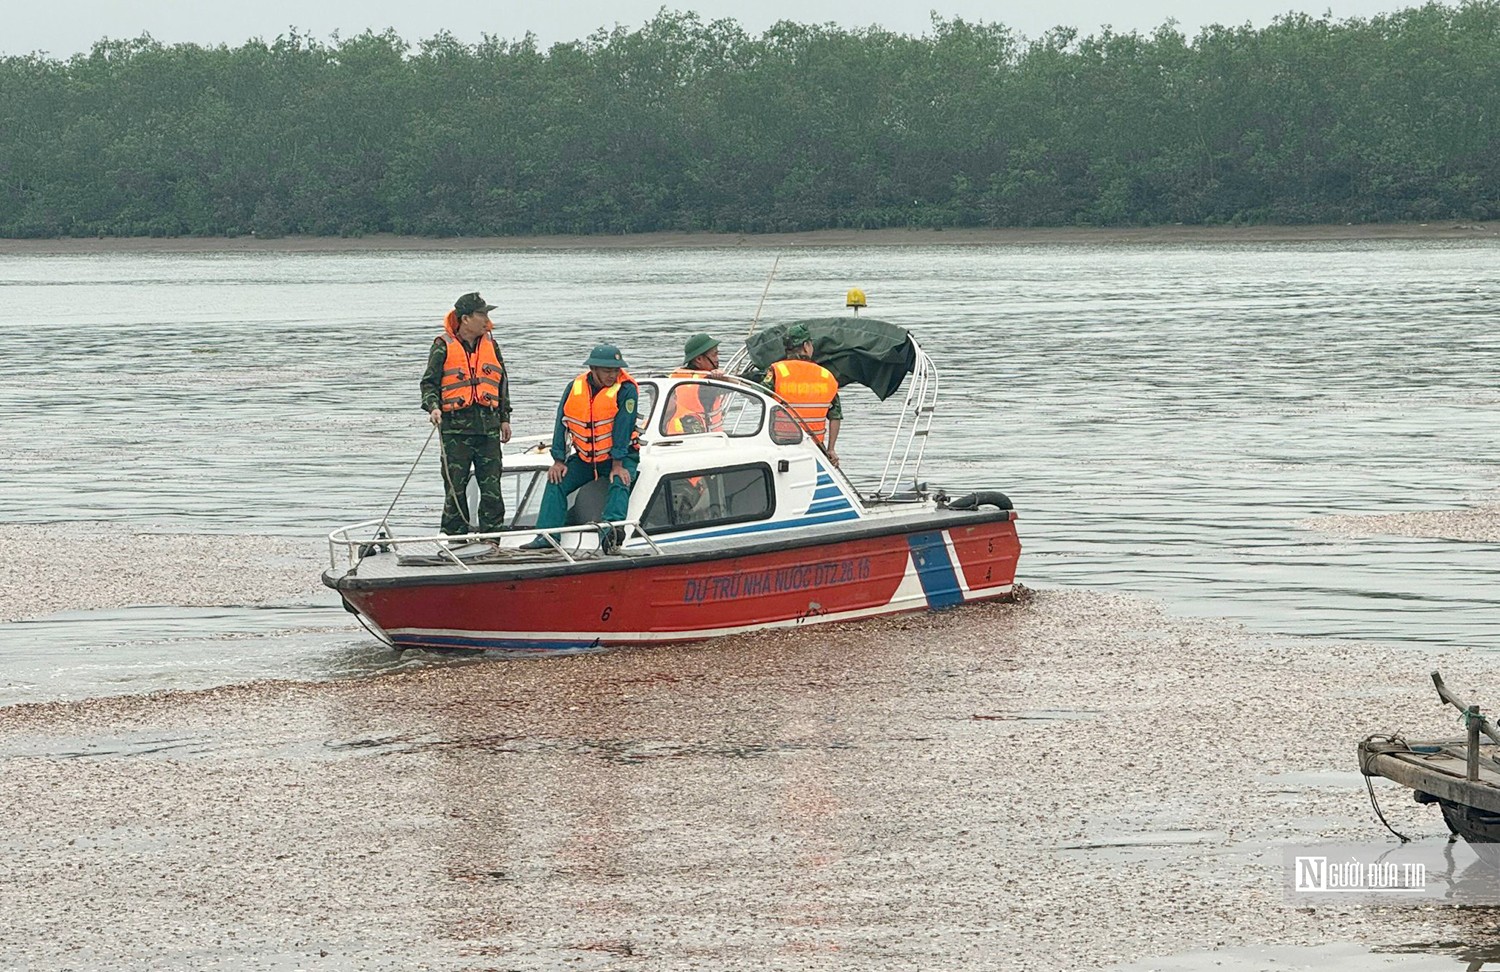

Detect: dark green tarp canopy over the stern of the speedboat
746,315,917,399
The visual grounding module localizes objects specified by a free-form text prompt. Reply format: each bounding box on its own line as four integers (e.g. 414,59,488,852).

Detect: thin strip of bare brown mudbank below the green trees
0,221,1500,255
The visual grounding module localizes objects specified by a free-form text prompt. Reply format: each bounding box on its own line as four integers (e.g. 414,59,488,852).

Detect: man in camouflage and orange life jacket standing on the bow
422,293,510,534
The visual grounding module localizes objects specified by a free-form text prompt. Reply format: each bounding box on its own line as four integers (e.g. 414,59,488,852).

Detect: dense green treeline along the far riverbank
0,0,1500,237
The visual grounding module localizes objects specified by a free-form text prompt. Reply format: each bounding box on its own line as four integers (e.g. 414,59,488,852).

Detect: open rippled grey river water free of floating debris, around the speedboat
0,242,1500,705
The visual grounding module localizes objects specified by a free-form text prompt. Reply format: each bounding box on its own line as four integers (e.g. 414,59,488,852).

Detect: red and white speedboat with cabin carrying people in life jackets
323,318,1020,651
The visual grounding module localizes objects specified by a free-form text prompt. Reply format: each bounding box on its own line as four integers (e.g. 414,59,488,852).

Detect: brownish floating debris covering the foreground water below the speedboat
0,591,1500,969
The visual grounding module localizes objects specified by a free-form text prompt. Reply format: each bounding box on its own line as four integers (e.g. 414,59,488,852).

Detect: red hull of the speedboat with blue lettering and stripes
326,512,1020,651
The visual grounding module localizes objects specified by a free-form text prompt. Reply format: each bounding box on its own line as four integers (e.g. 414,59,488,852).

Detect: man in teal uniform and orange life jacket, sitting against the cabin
524,345,641,551
